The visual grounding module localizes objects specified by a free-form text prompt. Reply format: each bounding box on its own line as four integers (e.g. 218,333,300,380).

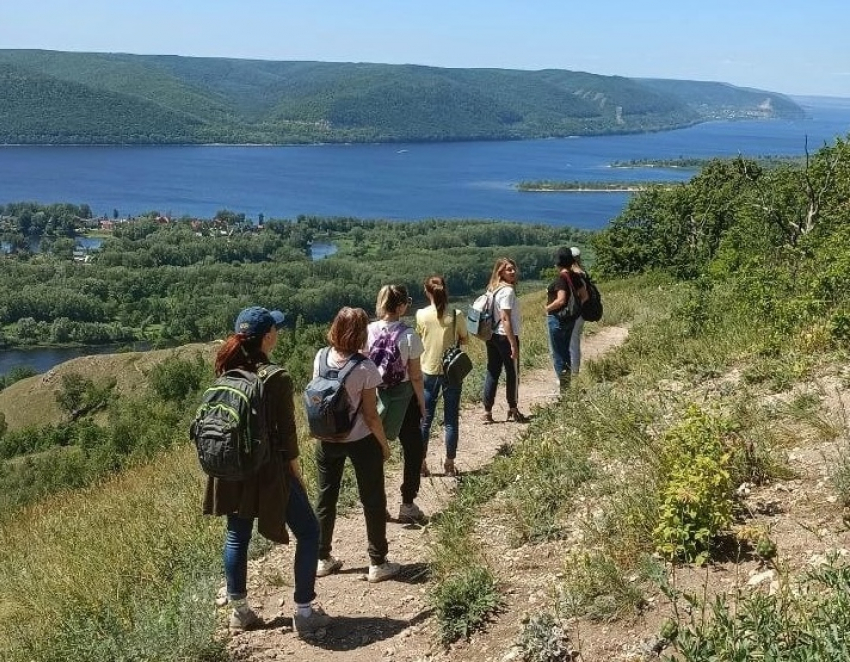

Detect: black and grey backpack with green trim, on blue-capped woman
189,365,283,480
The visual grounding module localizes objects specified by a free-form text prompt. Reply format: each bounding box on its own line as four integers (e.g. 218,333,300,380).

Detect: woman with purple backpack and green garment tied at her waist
367,285,425,522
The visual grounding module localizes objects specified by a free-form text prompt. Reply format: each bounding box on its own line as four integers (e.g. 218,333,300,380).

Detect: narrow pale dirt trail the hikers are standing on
229,327,628,662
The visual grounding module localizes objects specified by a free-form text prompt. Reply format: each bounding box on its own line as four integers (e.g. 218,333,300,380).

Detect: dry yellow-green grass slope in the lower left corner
0,447,223,662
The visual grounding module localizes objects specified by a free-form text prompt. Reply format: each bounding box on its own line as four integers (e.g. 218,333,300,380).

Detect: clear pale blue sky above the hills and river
0,0,850,97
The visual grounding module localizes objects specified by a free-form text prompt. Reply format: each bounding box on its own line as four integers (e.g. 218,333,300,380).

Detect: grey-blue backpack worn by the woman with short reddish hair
304,347,366,441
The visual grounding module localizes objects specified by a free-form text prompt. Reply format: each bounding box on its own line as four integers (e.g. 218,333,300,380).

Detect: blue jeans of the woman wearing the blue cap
224,476,319,604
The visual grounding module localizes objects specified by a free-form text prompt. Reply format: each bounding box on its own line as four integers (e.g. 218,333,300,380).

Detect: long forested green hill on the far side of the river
0,50,803,144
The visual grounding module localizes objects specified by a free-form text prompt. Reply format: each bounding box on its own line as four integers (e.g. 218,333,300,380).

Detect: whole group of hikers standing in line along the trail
203,248,587,637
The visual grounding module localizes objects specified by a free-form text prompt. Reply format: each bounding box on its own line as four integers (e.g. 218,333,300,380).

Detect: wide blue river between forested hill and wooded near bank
0,98,850,228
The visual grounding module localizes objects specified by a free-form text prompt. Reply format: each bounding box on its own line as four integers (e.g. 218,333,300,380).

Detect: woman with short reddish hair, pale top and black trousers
313,307,401,582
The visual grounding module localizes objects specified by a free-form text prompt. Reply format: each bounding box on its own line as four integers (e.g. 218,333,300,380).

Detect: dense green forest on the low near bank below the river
0,215,589,346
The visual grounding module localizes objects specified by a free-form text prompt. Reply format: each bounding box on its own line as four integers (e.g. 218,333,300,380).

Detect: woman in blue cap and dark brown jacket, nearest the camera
204,306,330,636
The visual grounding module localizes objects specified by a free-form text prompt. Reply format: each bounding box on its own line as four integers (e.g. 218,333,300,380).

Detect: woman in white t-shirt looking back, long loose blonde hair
481,257,528,424
